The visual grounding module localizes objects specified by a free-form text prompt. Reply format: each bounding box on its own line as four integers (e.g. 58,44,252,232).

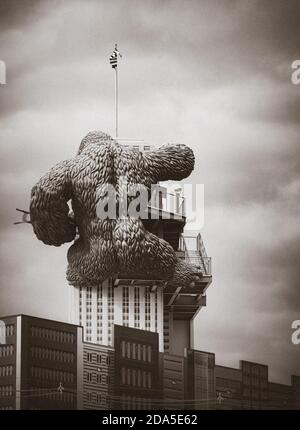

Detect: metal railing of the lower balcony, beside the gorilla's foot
179,233,211,276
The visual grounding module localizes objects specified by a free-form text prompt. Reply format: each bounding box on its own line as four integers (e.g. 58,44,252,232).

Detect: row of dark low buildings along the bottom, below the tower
0,315,300,410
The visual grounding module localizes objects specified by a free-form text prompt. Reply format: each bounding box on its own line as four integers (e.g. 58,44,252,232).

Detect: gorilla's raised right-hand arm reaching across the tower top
143,145,195,182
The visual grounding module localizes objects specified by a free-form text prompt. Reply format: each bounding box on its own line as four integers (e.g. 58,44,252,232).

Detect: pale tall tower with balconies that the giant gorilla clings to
69,140,212,356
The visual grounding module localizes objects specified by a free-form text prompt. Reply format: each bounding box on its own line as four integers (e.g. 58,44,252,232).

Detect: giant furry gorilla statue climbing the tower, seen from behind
30,131,201,286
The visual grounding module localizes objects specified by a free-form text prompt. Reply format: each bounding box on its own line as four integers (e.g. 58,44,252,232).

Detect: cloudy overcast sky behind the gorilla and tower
0,0,300,383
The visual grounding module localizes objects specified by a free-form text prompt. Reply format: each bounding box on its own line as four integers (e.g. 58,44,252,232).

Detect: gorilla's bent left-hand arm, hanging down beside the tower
30,160,76,246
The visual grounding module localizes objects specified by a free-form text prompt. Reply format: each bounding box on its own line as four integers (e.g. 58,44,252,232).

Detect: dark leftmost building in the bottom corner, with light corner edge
0,315,82,410
